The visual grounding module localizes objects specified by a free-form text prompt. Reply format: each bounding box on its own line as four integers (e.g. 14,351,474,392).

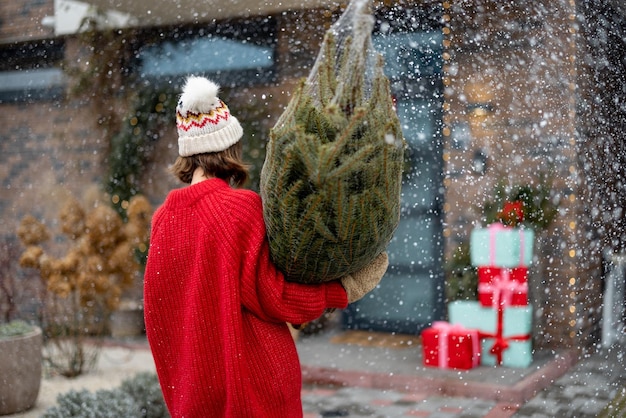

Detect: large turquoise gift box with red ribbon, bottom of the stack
448,301,533,367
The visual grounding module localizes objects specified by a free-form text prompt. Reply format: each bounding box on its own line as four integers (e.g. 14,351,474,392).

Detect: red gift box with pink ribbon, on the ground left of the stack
422,321,480,370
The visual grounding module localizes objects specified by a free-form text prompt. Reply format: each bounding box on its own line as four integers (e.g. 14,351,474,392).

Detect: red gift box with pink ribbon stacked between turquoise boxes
478,266,528,308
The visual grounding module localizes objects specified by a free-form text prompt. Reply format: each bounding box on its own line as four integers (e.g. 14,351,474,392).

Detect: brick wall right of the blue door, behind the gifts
444,0,624,349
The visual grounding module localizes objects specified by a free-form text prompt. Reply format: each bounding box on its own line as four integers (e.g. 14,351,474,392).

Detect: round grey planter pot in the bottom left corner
0,327,43,415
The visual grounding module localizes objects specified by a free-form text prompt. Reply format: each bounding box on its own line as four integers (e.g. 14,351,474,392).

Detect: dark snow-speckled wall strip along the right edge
570,1,626,350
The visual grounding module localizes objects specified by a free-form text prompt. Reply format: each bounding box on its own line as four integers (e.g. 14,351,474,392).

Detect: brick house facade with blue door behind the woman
0,0,626,349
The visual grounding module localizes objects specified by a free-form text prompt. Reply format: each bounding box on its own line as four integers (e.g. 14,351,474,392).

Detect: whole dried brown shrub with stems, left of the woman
17,195,152,377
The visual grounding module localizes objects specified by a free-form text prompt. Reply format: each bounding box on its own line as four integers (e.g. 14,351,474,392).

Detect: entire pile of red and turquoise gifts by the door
422,202,534,369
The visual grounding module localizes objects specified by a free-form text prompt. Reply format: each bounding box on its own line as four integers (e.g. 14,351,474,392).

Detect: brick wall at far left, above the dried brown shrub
0,95,106,235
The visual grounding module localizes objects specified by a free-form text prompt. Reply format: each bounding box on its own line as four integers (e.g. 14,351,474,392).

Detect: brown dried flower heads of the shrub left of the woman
18,196,152,310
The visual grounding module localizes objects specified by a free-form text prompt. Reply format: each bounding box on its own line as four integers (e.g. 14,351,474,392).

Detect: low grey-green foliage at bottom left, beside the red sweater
42,372,169,418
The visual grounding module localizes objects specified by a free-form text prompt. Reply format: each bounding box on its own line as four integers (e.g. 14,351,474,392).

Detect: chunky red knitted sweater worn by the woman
144,179,348,418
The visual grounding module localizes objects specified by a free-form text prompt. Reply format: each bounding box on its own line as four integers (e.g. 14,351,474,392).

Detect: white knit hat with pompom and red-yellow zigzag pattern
176,77,243,157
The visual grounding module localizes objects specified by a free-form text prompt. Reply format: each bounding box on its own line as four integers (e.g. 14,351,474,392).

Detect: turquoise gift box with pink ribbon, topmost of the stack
470,223,535,267
